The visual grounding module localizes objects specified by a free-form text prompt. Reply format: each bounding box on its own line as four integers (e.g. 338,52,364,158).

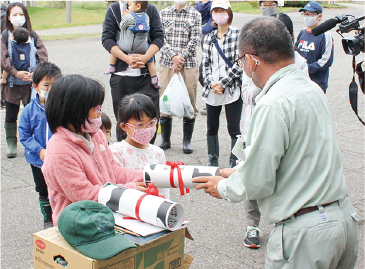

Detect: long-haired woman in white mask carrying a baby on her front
1,3,48,158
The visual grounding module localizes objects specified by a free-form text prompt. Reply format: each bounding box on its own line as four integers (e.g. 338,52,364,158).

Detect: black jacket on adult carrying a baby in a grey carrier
101,2,164,73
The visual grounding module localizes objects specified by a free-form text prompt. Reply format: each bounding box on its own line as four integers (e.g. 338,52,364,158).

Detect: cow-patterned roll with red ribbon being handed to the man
143,162,220,195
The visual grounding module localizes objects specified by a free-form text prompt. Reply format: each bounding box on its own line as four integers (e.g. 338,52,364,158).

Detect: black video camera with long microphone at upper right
312,14,365,56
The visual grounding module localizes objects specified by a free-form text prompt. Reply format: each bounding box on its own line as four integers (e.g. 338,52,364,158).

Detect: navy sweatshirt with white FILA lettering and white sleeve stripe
295,29,333,92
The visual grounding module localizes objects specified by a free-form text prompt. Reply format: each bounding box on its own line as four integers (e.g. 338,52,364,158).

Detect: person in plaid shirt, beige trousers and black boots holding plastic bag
158,1,202,154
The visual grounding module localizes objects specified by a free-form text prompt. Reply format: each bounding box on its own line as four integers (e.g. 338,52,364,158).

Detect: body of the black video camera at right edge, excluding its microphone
336,15,365,56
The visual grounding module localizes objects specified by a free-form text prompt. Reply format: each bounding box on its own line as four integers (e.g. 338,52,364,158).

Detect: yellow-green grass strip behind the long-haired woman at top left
28,7,106,30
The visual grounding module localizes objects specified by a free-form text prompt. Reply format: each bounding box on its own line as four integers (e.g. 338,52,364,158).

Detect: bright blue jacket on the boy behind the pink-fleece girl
18,94,53,165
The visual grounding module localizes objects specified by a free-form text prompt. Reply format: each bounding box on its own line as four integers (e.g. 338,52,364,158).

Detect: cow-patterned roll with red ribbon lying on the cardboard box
98,183,184,231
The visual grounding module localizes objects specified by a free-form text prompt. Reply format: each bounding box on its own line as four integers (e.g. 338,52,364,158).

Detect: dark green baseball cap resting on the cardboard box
58,200,136,260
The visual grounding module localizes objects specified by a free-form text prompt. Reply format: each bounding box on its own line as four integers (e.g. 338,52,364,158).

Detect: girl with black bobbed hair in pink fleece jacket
42,75,145,225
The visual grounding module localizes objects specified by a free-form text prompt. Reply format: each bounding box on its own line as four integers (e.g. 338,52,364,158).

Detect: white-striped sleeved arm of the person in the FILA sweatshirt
308,32,333,74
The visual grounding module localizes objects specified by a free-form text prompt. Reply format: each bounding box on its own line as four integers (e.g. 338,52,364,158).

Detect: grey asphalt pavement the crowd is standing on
0,2,365,269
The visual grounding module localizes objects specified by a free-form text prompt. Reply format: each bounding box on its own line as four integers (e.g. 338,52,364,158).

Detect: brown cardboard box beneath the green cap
33,227,192,269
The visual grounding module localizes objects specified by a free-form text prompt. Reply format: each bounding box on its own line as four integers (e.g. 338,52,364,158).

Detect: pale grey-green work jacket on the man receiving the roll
218,64,347,224
